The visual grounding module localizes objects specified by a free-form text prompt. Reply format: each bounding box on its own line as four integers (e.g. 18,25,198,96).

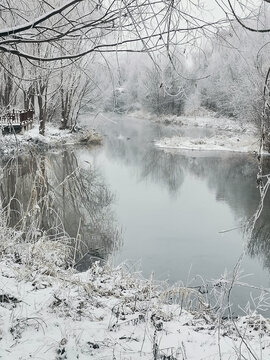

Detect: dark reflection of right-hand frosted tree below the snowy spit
181,154,270,270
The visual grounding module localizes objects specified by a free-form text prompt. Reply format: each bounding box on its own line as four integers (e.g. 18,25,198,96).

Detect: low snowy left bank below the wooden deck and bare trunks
0,124,102,157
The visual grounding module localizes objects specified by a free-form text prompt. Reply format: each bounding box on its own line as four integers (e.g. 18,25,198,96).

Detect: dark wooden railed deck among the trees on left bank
0,109,34,134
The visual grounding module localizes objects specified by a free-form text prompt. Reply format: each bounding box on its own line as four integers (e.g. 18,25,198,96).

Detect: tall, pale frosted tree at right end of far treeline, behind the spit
179,22,270,124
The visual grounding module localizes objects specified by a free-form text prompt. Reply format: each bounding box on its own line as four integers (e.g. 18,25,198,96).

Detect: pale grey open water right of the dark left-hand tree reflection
77,117,270,314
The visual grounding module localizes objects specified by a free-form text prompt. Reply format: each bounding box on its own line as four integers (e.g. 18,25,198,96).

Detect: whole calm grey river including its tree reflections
1,115,270,313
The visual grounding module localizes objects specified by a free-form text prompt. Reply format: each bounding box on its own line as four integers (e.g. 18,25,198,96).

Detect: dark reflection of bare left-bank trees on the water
1,151,119,268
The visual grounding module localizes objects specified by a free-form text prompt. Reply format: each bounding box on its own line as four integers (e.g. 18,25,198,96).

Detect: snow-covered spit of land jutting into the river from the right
155,116,259,152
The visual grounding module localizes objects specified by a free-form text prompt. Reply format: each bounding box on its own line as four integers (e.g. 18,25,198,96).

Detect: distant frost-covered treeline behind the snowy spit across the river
96,24,270,128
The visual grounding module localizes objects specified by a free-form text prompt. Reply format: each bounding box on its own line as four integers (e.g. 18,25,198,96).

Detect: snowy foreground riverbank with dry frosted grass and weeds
0,228,270,360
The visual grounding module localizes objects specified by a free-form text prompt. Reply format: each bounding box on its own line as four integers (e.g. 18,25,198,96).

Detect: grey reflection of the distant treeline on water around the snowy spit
101,115,260,219
